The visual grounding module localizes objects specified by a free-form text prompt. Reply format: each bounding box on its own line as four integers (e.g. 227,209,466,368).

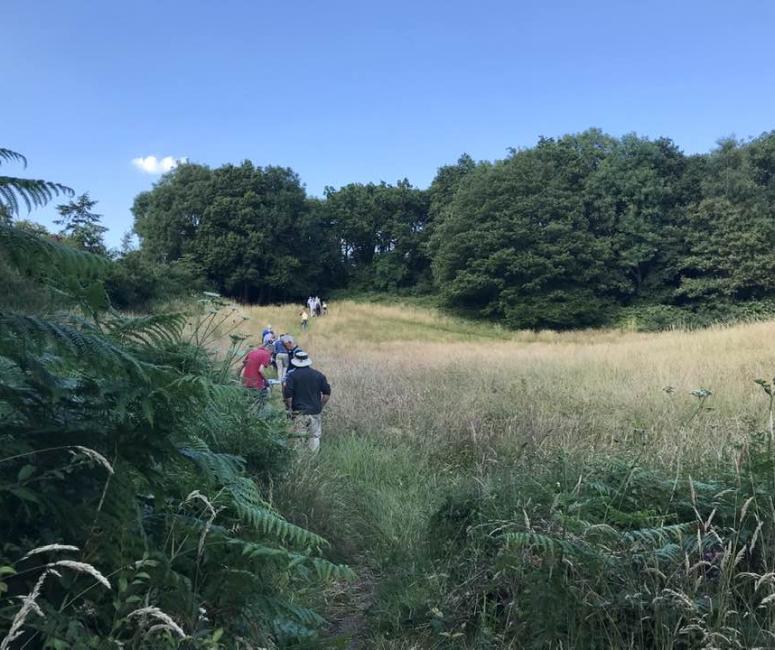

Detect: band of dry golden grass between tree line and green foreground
221,302,775,465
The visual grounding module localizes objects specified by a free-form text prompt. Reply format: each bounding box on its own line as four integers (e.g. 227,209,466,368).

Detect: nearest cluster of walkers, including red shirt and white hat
240,312,331,451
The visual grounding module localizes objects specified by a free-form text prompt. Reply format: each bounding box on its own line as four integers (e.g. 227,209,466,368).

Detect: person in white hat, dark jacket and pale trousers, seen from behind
283,350,331,451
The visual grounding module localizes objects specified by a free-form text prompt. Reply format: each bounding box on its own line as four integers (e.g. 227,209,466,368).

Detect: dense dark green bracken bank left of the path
0,226,352,650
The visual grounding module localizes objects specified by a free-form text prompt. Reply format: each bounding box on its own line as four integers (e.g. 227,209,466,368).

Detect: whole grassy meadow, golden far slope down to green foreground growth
202,301,775,648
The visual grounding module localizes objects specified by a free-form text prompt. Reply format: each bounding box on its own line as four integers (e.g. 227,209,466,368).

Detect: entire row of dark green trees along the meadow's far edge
12,129,775,328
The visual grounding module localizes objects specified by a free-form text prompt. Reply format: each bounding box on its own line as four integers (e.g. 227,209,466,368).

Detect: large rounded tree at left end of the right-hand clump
432,131,617,327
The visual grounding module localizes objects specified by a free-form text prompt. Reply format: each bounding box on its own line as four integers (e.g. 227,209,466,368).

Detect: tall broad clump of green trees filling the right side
432,130,775,327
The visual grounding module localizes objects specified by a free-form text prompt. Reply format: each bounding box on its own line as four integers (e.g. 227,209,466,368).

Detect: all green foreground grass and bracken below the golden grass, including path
276,404,775,650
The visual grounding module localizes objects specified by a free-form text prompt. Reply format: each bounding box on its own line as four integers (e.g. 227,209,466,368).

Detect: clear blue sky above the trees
0,0,775,245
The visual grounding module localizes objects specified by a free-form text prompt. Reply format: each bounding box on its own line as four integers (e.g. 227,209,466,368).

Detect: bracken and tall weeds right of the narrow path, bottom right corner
421,439,775,648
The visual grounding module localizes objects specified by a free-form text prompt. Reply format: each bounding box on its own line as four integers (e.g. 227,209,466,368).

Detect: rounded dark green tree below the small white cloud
133,162,336,302
